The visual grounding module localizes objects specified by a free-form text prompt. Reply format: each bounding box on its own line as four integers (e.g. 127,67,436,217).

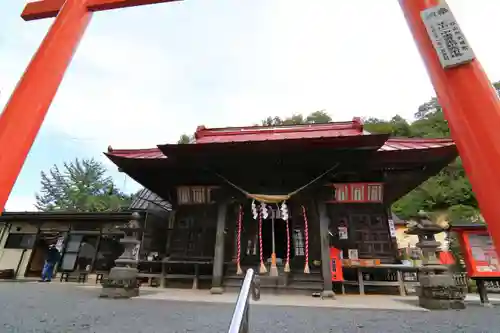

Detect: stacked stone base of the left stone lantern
99,267,139,299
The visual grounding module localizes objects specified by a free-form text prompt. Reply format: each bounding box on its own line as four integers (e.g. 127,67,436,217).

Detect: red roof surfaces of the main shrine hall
107,118,455,159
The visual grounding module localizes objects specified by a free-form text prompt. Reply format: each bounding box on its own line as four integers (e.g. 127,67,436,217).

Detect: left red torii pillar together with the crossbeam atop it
0,0,179,213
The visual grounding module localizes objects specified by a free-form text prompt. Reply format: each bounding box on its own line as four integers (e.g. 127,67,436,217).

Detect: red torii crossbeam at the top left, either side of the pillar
21,0,182,21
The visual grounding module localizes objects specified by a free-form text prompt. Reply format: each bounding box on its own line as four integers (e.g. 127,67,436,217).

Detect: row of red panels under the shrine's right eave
330,183,383,203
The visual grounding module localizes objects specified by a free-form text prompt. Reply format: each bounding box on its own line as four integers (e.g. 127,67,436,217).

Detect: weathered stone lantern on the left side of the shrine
100,212,141,298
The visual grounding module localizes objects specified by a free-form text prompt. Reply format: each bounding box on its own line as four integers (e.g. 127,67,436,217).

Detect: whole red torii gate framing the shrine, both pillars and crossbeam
0,0,500,256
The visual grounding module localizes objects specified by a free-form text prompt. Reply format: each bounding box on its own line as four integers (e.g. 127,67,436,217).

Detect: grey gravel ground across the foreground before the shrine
0,283,500,333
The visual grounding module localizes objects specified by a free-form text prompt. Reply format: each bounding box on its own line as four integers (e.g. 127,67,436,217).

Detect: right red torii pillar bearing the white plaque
399,0,500,257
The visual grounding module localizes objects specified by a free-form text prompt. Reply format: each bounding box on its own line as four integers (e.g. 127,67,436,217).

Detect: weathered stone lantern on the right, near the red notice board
406,212,465,310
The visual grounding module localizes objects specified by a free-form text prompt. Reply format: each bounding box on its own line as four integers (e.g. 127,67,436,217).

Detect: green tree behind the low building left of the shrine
35,159,132,212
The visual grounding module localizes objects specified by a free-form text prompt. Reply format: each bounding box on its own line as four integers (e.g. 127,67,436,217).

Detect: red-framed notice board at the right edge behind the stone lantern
460,230,500,277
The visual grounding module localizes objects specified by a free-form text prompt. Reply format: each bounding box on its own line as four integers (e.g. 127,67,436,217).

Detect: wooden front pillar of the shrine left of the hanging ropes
210,202,228,294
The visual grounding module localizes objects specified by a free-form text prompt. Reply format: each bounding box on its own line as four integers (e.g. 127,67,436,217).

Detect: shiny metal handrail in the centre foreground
228,268,260,333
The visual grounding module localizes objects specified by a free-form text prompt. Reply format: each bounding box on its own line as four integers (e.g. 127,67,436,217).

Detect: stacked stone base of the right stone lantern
417,273,465,310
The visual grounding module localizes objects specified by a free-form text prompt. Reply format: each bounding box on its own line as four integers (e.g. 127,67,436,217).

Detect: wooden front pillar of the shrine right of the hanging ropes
318,200,335,298
